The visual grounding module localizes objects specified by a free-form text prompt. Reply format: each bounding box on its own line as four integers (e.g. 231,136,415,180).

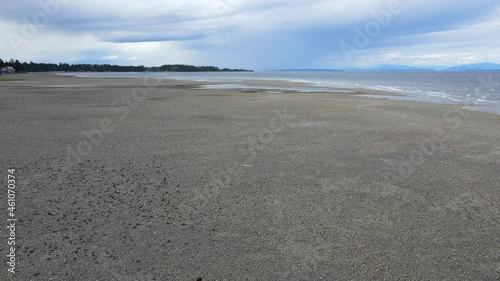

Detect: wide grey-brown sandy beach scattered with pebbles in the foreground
0,74,500,281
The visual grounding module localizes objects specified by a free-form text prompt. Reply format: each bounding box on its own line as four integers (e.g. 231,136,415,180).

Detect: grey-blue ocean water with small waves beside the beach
61,72,500,114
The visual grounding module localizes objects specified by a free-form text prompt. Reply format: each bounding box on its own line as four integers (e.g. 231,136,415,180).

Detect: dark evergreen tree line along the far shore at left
0,59,252,73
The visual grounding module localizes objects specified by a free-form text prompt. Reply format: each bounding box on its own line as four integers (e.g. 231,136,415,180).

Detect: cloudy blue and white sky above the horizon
0,0,500,70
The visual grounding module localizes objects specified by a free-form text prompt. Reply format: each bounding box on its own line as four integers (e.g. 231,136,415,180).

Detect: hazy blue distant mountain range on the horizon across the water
269,63,500,72
